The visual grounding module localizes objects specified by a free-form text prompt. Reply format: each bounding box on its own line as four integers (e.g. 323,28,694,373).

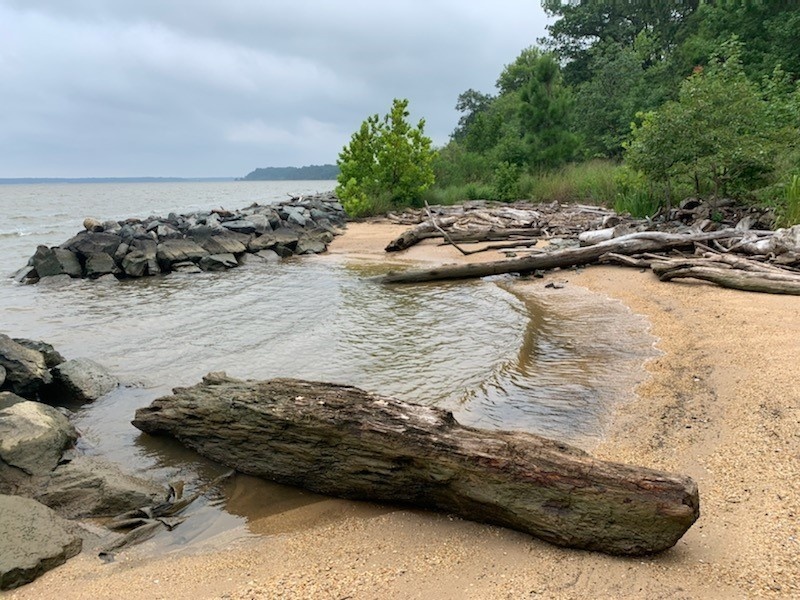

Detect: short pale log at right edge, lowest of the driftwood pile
652,260,800,296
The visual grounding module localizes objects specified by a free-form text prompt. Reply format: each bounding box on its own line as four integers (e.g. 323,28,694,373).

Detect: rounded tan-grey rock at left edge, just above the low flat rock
0,392,78,475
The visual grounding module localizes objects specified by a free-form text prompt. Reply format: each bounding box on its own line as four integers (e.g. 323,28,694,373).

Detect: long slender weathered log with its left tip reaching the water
381,229,741,283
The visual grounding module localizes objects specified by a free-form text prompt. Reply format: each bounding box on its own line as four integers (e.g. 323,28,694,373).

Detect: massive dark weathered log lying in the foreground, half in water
133,373,699,555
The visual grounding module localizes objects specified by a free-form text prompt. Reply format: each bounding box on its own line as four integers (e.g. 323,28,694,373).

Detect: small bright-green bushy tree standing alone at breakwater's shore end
336,99,436,217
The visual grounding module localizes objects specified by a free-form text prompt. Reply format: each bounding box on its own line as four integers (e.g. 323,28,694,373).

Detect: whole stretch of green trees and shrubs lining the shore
338,0,800,225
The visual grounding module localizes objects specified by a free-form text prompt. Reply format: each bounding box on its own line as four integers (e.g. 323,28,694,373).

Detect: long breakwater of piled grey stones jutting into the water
14,193,347,283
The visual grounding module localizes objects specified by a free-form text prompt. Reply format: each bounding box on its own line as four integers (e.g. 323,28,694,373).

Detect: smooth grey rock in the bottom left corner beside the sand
0,496,82,590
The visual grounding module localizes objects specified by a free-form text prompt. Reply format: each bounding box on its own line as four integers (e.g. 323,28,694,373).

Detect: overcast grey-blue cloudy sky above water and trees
0,0,548,178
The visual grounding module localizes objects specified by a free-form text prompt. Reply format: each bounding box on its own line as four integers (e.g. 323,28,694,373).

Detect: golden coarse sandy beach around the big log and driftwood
7,223,800,600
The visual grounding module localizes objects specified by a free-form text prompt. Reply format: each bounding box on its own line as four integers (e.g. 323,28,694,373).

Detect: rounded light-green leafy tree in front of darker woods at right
625,43,776,199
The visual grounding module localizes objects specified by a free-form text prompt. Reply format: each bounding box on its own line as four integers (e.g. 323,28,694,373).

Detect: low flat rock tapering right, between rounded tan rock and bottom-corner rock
36,456,164,519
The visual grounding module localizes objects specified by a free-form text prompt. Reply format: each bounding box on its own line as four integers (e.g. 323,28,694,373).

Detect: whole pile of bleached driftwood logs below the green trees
383,204,800,295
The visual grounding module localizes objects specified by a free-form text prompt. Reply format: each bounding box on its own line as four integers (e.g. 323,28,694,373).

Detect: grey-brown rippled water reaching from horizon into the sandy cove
0,181,654,549
